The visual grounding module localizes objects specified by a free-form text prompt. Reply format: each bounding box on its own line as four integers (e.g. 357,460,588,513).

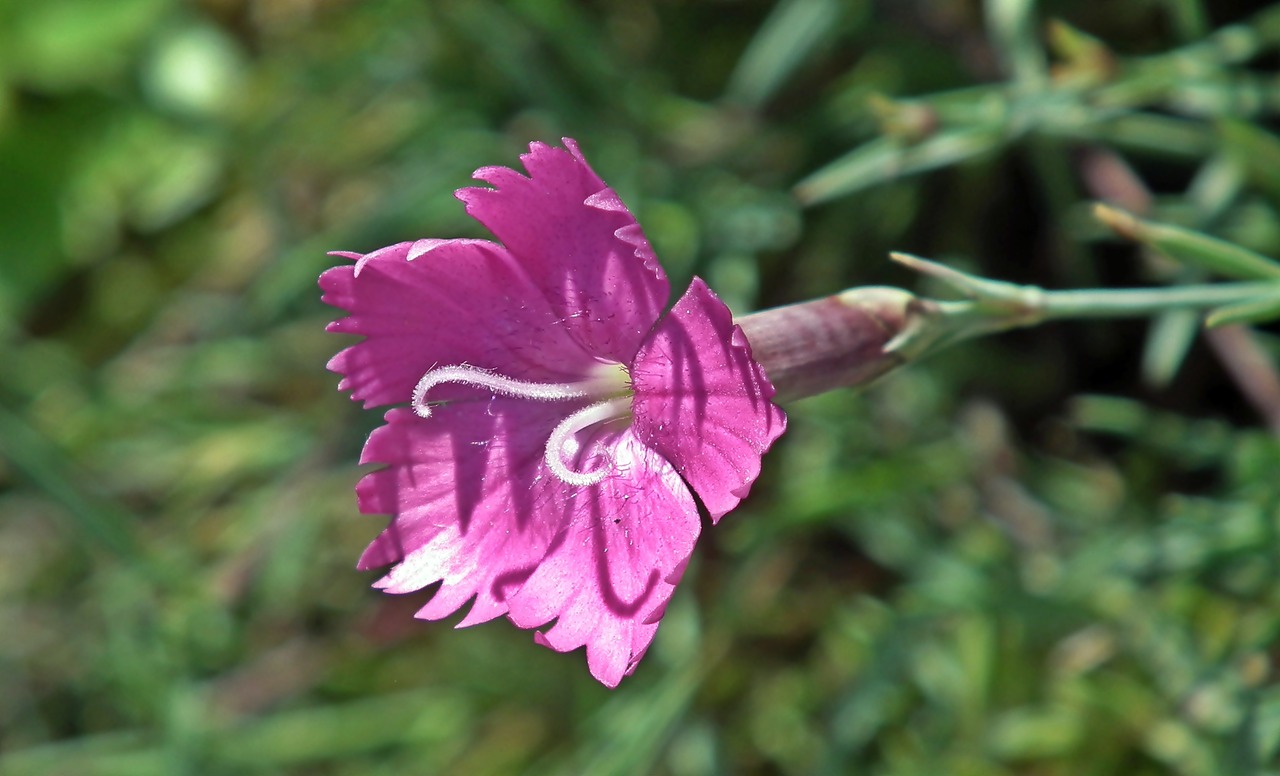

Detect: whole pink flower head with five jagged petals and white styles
320,138,786,686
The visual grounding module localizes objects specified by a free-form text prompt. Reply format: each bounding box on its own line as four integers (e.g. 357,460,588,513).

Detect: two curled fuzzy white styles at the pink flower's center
411,364,631,487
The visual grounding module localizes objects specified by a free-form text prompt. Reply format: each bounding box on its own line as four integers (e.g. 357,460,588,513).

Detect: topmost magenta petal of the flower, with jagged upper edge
457,138,671,364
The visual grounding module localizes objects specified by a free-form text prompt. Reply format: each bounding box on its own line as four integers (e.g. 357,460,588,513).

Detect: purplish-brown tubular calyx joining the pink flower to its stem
737,287,937,402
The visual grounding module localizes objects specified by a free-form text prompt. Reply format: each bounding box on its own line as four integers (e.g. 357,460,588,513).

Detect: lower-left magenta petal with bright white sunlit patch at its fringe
357,400,581,625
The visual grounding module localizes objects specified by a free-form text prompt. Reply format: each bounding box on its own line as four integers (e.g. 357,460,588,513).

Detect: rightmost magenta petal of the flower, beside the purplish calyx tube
631,278,786,521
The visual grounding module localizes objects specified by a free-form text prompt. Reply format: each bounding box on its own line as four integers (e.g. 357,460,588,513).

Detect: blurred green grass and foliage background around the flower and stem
0,0,1280,776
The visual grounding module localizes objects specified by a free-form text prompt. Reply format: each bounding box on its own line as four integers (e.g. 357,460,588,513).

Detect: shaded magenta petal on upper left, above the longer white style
320,239,596,407
